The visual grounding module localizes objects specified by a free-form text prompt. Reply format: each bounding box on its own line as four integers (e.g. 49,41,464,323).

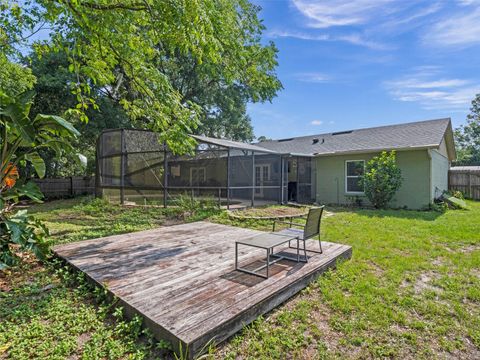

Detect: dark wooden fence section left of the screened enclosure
33,176,95,199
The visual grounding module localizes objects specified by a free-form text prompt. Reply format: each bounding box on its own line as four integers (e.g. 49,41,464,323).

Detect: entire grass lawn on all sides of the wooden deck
0,200,480,359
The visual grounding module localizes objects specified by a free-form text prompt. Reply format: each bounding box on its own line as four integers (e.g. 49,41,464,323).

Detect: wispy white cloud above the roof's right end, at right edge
385,67,480,110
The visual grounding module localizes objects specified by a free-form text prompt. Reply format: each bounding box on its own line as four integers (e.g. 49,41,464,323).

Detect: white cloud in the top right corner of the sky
423,7,480,46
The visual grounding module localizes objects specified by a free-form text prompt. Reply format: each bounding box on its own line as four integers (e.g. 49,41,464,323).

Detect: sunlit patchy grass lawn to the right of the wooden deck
217,202,480,359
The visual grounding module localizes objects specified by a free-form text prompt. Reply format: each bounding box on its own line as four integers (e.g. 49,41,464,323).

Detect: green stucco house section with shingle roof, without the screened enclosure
256,118,456,209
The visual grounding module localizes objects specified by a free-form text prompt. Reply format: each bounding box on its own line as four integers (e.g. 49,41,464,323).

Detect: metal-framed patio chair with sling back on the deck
273,205,325,262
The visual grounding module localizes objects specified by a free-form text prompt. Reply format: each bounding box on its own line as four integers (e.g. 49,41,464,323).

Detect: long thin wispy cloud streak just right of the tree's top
267,30,390,50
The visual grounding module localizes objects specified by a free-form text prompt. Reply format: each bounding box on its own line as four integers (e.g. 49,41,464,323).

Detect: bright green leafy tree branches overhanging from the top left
0,0,281,152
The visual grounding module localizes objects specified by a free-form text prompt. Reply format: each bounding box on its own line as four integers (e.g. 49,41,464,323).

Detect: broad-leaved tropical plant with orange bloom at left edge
0,89,79,270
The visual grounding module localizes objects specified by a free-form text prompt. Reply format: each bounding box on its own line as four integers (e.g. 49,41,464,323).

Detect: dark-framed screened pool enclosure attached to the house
96,129,315,208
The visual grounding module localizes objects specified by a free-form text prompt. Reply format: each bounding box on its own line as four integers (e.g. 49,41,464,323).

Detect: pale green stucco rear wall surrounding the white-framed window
315,150,432,209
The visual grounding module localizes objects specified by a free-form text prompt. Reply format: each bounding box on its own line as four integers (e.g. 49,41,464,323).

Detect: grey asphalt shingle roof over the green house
255,118,450,156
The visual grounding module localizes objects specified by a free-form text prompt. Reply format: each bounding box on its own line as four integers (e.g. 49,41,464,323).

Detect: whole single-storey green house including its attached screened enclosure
96,119,455,209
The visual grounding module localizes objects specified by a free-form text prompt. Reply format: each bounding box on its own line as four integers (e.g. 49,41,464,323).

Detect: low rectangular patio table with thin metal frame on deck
235,233,307,279
